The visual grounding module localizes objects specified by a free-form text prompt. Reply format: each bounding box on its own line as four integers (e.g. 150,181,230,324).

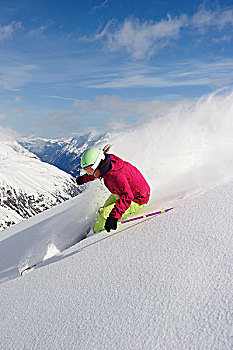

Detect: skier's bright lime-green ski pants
93,194,146,233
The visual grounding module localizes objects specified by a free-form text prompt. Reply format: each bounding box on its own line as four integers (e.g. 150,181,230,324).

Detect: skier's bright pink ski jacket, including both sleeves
81,154,150,220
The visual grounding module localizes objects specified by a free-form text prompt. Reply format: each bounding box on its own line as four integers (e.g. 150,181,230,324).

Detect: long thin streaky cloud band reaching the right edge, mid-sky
87,59,233,89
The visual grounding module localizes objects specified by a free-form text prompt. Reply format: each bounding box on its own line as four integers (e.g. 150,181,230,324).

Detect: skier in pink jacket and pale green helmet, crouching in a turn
76,145,150,232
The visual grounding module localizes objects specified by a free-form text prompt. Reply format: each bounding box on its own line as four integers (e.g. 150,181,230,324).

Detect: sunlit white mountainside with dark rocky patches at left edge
0,141,80,230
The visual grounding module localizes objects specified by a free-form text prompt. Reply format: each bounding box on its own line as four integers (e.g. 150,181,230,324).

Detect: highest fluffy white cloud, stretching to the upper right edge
80,6,233,59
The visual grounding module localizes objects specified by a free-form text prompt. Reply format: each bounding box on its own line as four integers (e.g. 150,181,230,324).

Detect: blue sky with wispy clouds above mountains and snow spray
0,0,233,138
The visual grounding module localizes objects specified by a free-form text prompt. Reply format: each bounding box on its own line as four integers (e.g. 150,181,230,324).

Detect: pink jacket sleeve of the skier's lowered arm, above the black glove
109,176,134,220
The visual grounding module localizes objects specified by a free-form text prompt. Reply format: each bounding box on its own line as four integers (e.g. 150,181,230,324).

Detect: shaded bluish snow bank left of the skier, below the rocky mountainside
0,181,106,281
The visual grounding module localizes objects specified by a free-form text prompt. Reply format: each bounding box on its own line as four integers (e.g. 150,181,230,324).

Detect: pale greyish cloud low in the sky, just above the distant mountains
40,95,174,132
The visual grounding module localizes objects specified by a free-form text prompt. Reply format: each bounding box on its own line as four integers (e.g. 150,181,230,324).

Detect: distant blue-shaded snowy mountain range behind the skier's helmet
18,132,109,176
